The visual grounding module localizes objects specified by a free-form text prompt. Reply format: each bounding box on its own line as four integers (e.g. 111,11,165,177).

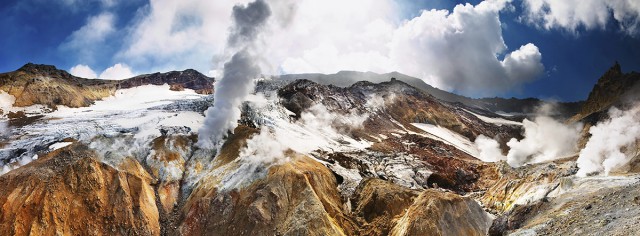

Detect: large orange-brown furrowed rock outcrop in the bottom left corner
0,144,160,235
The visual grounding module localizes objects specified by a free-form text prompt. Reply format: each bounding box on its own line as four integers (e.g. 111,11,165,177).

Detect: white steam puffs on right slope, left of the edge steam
475,106,582,167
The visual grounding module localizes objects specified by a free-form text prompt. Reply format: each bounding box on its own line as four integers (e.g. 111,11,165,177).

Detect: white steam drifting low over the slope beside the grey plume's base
219,101,369,191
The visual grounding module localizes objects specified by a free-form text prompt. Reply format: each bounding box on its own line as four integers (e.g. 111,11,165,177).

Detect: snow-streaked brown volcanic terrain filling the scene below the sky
0,63,640,235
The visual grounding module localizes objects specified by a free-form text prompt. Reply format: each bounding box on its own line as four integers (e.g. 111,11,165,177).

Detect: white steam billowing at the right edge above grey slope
577,105,640,176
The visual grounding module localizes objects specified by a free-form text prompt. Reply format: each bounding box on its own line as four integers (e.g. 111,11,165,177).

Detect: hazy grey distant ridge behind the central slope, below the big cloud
276,71,581,117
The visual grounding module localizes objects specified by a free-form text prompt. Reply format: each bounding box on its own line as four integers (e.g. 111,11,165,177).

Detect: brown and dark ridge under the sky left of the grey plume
0,63,214,108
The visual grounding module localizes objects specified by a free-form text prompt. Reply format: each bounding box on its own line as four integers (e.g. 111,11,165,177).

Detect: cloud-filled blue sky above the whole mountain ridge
0,0,640,101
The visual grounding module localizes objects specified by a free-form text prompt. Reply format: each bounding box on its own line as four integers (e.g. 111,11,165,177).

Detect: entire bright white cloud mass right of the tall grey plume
266,1,544,95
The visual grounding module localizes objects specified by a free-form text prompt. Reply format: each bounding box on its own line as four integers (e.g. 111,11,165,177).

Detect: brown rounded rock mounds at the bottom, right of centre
352,179,492,235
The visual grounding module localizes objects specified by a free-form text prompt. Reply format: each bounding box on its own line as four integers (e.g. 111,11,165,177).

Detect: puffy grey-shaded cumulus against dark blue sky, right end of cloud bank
391,1,544,95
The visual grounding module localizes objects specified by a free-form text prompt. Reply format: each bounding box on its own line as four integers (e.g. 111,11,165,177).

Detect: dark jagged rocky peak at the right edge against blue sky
571,62,640,121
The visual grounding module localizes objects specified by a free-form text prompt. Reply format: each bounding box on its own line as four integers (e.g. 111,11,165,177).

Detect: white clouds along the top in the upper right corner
523,0,640,35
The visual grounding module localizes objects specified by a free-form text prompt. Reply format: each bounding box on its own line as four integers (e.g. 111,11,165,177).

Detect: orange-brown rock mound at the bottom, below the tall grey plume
180,156,355,235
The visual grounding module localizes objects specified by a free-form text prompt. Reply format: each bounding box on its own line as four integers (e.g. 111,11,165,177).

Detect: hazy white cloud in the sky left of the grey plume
116,0,248,71
